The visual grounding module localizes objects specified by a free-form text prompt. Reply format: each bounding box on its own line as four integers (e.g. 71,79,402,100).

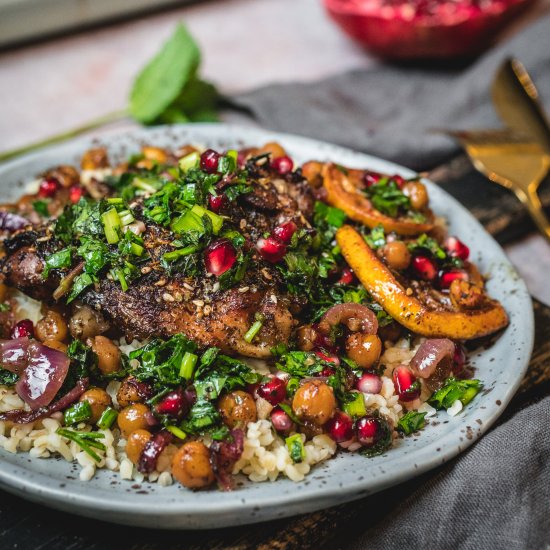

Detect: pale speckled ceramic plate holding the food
0,124,533,529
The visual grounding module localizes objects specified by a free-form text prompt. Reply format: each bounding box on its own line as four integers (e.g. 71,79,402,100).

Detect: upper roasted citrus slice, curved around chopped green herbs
323,163,434,235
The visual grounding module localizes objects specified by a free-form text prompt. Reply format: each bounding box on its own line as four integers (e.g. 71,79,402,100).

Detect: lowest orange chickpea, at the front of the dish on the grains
172,441,215,489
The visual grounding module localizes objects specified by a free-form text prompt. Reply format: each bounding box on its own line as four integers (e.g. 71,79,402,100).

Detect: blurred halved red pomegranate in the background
323,0,533,59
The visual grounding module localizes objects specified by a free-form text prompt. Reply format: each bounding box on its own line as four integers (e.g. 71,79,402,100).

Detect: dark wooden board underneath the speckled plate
0,157,550,550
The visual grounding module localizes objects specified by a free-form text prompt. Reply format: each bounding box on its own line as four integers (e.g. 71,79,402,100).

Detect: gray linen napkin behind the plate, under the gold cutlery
233,17,550,170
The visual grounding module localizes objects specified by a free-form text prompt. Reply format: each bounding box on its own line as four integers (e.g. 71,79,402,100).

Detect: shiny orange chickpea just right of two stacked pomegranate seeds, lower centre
292,380,336,426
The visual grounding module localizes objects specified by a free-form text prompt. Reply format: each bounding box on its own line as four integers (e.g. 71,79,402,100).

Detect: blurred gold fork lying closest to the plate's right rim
443,129,550,242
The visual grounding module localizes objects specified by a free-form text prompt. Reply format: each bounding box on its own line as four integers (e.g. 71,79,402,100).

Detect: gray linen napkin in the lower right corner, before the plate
336,394,550,550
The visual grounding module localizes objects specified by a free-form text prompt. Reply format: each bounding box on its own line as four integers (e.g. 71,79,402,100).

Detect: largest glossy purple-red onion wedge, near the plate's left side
15,342,71,410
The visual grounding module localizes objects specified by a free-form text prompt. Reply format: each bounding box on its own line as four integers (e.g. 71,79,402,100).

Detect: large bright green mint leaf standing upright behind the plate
129,24,200,124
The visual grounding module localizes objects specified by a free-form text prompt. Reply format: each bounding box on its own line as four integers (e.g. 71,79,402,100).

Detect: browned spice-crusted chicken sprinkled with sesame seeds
2,146,313,357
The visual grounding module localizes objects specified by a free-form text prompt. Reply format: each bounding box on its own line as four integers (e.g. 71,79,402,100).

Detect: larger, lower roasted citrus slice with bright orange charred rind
336,225,508,340
